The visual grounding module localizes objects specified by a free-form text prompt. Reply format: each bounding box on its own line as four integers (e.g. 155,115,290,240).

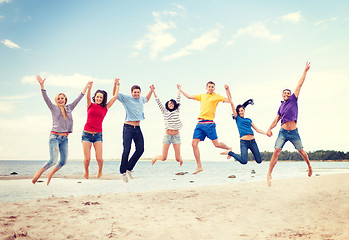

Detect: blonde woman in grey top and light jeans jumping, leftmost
32,76,92,185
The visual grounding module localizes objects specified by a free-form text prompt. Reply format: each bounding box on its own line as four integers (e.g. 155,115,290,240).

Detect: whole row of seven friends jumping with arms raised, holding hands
32,62,312,186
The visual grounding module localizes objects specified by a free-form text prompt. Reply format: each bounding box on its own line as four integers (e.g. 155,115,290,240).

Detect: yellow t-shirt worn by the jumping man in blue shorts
195,93,225,120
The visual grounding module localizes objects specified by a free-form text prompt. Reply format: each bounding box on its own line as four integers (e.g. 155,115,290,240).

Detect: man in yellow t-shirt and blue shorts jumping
177,81,231,174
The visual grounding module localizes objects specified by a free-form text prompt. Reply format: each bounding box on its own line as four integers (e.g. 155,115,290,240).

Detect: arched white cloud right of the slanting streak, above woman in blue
228,22,282,45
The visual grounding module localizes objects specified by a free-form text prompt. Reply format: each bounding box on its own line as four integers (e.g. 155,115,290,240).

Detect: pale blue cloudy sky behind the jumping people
0,0,349,161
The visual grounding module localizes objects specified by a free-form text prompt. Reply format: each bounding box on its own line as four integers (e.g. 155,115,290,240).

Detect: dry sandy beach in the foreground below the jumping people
0,174,349,240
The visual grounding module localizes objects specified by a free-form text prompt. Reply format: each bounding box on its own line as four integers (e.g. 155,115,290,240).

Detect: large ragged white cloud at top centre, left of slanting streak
131,11,177,60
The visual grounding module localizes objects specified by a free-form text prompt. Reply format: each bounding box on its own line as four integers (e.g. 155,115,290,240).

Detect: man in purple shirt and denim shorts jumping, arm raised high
267,62,313,186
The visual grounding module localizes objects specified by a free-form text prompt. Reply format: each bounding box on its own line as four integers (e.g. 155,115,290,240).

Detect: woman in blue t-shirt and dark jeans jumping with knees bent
221,85,267,164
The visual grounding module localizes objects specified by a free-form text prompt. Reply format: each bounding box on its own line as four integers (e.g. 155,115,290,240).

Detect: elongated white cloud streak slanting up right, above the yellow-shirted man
163,29,221,61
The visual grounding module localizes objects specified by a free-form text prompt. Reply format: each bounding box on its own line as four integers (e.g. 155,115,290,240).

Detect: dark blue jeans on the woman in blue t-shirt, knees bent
228,139,262,164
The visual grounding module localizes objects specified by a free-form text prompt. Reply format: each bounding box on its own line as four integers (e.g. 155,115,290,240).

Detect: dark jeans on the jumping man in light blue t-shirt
120,124,144,173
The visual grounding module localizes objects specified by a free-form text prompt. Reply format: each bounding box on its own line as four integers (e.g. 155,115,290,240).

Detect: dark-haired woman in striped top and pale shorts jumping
151,84,183,166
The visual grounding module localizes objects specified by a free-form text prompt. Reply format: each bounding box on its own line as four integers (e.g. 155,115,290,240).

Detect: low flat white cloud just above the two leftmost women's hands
22,73,113,89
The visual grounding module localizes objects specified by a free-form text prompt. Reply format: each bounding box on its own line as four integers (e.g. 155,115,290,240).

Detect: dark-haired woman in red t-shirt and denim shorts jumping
81,78,119,179
